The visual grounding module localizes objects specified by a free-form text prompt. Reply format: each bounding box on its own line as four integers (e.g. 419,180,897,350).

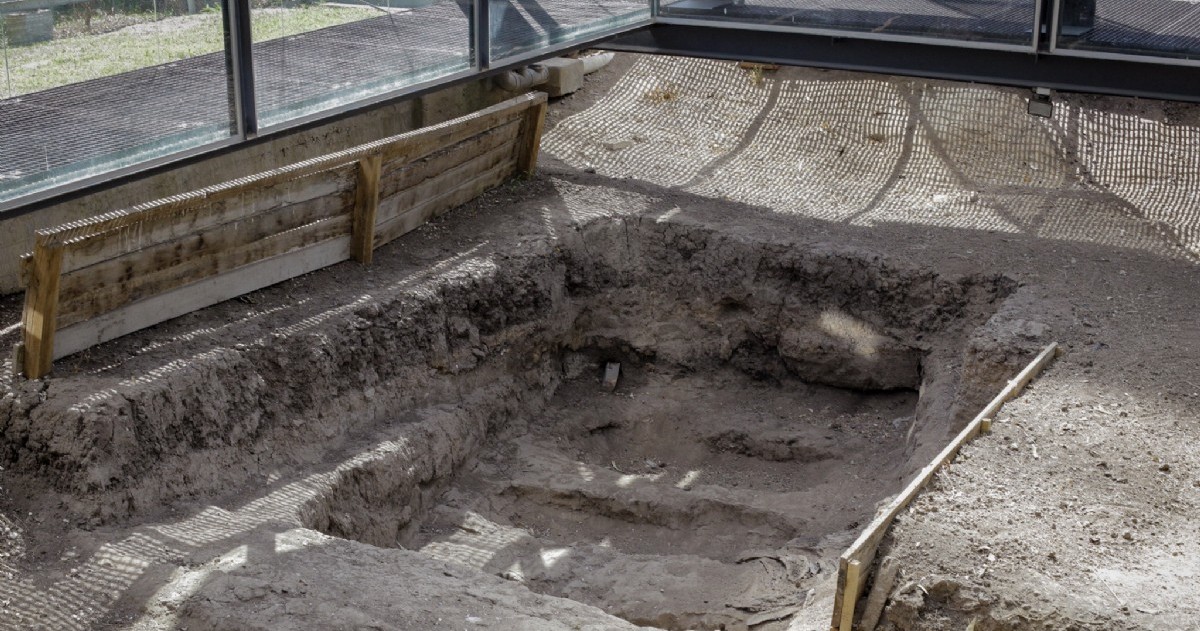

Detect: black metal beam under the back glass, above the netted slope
601,23,1200,102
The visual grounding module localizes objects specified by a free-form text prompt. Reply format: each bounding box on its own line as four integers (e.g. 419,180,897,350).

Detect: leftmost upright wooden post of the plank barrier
22,233,62,379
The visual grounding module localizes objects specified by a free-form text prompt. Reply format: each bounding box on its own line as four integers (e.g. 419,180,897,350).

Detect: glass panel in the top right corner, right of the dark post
1057,0,1200,59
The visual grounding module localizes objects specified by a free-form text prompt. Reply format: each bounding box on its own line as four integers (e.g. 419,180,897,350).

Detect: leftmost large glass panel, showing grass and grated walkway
0,0,230,202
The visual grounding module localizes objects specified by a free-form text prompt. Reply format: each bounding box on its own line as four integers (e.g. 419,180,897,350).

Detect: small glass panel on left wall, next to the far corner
488,0,650,60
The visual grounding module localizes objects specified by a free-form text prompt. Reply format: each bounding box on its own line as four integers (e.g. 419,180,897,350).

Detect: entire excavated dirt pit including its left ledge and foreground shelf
0,212,1045,631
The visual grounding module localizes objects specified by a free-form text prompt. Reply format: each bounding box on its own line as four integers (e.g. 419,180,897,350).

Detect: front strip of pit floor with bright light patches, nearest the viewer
419,507,833,630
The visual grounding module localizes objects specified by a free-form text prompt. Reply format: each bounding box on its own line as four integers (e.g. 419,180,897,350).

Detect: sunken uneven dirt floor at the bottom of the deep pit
417,369,917,629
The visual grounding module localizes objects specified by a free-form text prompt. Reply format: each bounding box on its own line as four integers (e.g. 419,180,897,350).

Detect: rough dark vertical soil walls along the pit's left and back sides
0,217,1037,527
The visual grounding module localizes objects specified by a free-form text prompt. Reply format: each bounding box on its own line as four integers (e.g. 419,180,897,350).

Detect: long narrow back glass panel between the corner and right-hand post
659,0,1037,46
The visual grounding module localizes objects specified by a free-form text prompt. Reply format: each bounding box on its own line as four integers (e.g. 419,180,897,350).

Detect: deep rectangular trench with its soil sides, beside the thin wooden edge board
285,221,1016,630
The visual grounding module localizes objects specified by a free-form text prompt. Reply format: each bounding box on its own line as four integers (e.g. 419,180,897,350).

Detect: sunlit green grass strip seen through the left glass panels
0,5,383,97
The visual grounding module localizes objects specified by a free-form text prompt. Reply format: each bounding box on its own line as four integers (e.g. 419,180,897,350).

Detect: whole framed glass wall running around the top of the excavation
0,0,1200,208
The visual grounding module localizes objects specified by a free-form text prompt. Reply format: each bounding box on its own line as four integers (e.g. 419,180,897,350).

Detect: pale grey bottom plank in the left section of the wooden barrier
54,235,350,359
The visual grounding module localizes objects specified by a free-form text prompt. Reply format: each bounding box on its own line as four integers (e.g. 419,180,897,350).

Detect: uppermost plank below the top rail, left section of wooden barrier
64,167,354,274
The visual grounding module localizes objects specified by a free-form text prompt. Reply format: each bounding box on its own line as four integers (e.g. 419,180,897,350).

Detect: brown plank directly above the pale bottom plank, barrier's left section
59,215,350,327
